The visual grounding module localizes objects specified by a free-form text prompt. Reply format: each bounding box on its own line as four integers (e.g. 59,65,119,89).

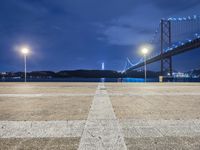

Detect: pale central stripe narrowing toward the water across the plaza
79,84,127,150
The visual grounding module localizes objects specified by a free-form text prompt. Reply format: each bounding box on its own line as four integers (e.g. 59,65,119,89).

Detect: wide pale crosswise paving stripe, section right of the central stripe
120,120,200,138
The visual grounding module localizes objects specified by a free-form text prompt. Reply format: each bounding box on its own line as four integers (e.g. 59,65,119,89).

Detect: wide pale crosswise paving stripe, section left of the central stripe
0,120,85,138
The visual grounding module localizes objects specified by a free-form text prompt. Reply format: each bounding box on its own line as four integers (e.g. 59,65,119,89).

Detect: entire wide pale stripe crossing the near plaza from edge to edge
0,119,200,139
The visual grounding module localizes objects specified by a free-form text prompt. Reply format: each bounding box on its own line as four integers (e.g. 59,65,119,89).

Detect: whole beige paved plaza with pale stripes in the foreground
0,83,200,150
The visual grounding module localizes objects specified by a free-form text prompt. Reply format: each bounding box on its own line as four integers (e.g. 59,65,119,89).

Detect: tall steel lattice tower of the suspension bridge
160,19,172,76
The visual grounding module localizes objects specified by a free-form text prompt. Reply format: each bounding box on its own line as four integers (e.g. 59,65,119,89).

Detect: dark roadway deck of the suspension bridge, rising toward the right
126,38,200,72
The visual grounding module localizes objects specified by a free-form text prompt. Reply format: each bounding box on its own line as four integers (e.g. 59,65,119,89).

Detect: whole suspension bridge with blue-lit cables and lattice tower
124,15,200,76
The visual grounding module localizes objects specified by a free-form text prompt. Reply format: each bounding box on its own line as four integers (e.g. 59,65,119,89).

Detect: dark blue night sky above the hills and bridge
0,0,200,71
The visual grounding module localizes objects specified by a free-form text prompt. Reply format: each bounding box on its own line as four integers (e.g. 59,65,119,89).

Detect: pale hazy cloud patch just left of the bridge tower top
97,4,162,45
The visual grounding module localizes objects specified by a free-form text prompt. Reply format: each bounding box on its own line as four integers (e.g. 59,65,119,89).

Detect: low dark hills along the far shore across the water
0,69,200,78
